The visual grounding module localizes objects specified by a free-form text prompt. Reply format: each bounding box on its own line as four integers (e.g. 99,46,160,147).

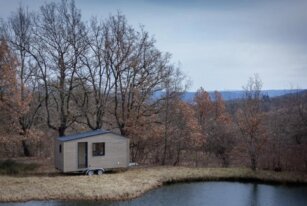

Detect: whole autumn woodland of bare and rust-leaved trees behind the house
0,0,307,171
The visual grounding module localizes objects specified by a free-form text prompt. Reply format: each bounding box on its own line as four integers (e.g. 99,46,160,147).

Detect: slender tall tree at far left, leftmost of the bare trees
4,7,42,136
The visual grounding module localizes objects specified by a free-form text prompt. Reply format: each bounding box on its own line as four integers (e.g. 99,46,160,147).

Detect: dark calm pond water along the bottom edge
0,182,307,206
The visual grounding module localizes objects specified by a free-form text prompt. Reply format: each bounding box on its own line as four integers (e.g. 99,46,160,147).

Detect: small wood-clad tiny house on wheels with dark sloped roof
55,129,129,175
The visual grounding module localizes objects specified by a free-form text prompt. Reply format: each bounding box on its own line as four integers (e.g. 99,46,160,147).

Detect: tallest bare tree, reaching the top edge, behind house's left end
31,0,87,136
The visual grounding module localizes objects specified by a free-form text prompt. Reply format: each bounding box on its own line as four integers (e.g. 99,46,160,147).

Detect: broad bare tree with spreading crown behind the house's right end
104,14,177,136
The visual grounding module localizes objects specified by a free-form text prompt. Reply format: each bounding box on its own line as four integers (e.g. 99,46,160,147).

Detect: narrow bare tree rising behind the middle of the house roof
75,18,115,129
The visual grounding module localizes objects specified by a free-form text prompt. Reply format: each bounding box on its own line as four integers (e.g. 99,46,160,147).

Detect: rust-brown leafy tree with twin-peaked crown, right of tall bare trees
194,88,234,167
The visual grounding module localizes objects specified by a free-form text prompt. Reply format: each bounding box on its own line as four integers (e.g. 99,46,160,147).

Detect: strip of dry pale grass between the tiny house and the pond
0,167,307,202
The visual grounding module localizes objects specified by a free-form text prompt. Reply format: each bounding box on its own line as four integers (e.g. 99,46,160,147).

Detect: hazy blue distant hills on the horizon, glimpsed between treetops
183,89,304,102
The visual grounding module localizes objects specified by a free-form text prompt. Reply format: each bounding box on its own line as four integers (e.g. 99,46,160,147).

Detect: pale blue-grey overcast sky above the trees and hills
0,0,307,90
